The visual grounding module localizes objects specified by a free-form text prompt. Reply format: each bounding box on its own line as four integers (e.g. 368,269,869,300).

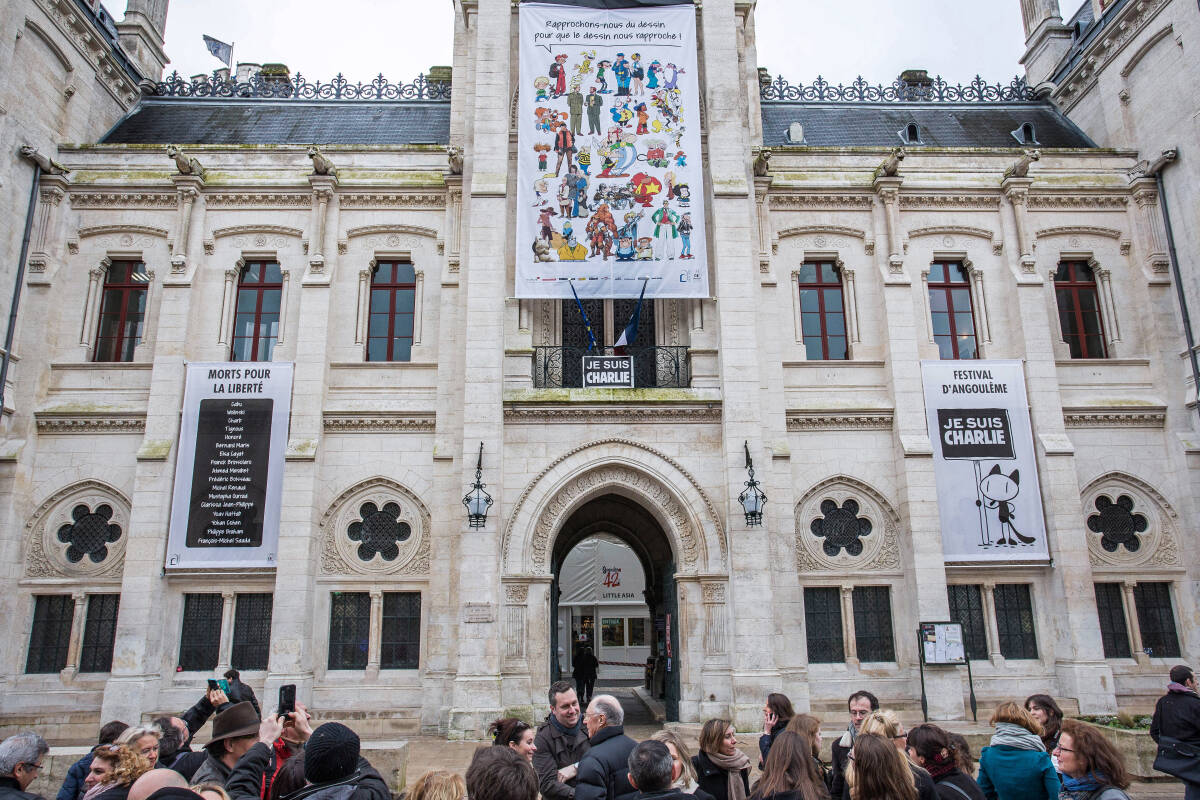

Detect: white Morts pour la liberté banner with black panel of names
166,361,293,570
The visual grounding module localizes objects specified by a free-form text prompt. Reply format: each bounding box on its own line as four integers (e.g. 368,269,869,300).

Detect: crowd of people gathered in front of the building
0,666,1200,800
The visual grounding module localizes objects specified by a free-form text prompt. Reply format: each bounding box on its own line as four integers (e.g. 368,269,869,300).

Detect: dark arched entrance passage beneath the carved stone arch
550,494,682,721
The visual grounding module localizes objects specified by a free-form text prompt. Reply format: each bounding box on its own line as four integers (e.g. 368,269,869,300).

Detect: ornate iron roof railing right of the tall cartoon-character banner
758,76,1038,103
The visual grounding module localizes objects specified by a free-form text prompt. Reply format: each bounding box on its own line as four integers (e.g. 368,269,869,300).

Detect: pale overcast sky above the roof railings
129,0,1032,84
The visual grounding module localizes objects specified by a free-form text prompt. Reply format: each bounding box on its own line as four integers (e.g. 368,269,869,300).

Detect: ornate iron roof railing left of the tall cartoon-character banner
150,71,450,100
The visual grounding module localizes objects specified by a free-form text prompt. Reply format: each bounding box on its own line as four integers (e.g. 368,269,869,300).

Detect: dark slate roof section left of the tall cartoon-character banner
101,97,450,145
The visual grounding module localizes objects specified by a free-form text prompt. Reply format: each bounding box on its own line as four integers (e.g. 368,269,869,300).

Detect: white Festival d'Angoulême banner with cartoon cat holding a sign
920,361,1050,564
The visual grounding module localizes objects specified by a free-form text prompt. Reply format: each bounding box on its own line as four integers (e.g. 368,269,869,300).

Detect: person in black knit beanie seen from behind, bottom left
288,722,386,800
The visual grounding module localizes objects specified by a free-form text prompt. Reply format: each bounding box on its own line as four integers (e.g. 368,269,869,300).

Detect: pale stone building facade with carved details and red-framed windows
0,0,1200,739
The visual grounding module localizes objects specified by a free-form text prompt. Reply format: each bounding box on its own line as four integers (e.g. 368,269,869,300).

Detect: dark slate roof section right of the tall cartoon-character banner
762,102,1096,148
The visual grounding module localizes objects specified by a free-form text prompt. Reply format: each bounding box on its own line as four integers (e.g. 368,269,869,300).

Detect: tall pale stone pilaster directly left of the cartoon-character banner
444,0,516,735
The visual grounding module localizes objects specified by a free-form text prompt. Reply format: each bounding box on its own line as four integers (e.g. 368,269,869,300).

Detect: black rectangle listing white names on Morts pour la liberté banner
187,398,275,547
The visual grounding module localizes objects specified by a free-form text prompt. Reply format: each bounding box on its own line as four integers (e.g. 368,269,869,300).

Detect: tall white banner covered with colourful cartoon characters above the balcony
516,1,709,299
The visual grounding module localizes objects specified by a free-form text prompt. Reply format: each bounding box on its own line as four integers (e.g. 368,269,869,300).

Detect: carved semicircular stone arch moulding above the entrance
502,438,728,575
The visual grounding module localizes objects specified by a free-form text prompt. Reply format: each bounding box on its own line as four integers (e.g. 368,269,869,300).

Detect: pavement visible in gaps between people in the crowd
406,688,1183,800
